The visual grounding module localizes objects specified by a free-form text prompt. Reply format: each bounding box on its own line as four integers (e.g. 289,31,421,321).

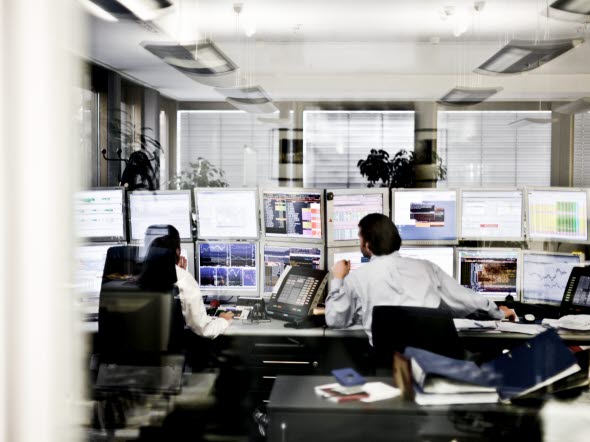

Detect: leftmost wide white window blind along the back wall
178,111,278,187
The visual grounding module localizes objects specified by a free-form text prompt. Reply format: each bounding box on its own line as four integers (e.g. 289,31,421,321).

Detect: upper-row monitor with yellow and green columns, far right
526,188,588,243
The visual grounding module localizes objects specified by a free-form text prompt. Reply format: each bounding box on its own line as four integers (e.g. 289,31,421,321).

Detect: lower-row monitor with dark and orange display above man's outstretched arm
457,248,520,301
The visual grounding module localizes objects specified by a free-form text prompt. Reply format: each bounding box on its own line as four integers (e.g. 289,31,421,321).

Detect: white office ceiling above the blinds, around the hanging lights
82,0,590,101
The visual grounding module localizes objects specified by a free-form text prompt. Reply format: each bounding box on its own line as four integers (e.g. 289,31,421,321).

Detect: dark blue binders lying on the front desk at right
404,330,580,403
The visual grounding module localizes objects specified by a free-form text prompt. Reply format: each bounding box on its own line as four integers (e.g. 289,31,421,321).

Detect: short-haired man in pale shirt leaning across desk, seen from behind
326,213,516,345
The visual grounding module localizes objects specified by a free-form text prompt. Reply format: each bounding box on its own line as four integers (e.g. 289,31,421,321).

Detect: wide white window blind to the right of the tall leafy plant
437,111,551,187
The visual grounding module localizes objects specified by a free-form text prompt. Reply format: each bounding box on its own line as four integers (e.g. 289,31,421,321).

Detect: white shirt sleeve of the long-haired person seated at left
176,266,230,339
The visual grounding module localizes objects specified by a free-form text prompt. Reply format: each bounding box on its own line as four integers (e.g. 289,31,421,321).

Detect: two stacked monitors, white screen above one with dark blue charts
195,188,260,297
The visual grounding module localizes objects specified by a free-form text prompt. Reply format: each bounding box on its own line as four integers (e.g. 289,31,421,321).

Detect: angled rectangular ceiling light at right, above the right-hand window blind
475,38,584,75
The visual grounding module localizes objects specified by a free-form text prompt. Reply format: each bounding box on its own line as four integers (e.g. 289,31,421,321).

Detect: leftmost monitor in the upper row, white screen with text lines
74,188,127,242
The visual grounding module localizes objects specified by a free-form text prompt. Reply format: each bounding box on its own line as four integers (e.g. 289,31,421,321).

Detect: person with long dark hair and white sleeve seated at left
145,226,234,339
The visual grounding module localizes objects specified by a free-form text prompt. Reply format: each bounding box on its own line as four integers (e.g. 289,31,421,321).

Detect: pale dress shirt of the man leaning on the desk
326,252,504,345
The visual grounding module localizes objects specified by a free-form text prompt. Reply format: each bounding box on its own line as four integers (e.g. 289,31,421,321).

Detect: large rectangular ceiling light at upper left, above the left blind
141,40,238,86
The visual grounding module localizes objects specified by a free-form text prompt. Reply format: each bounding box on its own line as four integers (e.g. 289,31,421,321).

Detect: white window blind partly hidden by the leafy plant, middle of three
303,111,414,187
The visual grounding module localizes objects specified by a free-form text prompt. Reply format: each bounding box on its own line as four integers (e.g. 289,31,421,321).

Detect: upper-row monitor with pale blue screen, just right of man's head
392,189,458,245
